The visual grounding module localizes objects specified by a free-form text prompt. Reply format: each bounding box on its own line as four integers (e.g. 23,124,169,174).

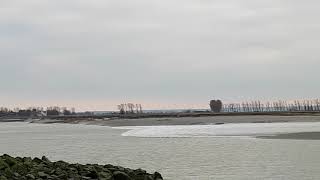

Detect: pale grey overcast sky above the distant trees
0,0,320,110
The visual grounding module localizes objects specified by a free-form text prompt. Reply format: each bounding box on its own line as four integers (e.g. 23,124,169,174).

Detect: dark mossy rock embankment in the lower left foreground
0,155,162,180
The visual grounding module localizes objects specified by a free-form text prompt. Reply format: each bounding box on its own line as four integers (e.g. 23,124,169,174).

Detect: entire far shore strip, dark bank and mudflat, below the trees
0,112,320,127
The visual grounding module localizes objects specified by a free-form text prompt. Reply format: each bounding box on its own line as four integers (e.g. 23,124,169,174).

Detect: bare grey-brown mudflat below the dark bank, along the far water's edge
32,115,320,127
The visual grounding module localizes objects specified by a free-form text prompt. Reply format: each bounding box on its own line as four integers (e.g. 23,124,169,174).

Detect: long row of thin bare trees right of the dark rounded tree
222,99,320,112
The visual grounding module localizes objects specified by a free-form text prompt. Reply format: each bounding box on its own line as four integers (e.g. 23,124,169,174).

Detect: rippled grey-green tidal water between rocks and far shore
0,122,320,180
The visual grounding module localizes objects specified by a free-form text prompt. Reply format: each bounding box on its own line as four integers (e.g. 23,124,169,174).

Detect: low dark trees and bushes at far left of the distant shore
0,106,76,117
